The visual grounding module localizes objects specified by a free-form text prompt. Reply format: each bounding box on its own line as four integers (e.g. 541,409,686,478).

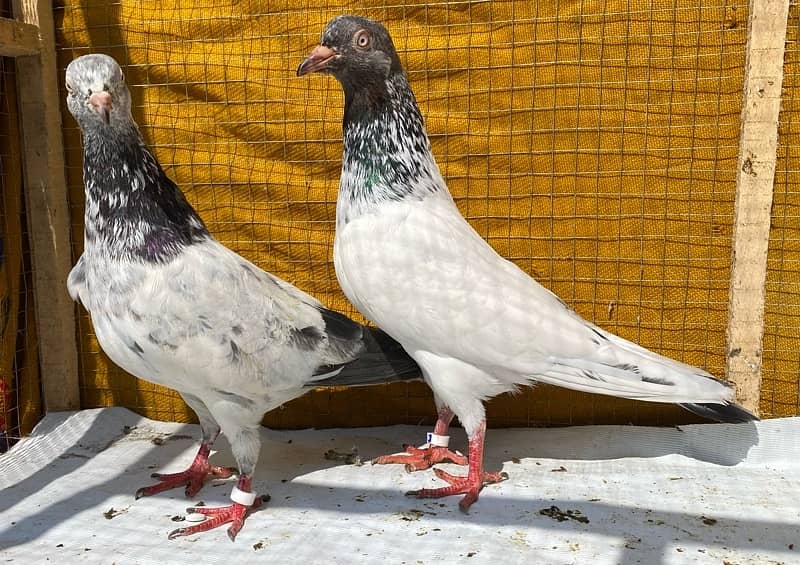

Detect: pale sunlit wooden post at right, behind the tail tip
726,0,789,412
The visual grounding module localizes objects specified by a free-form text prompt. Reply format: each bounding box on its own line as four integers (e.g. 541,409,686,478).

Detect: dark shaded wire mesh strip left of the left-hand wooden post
0,57,41,453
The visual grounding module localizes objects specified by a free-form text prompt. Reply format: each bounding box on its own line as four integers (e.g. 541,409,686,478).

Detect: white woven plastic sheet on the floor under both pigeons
0,408,800,565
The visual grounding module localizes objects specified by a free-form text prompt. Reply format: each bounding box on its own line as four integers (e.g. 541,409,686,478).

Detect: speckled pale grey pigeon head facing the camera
66,54,132,130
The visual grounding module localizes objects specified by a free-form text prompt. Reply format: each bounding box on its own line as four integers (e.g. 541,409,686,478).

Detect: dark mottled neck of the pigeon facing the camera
83,123,209,263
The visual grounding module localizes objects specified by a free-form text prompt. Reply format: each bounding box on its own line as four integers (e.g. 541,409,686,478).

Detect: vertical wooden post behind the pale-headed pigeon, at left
13,0,80,411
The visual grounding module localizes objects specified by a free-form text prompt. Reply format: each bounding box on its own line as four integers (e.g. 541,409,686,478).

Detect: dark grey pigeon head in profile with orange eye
297,16,403,92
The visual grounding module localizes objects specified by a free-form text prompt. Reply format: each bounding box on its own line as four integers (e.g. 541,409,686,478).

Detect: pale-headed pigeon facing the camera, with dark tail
66,55,419,540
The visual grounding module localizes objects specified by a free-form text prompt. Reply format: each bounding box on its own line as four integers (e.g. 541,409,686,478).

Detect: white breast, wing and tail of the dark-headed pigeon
335,189,732,403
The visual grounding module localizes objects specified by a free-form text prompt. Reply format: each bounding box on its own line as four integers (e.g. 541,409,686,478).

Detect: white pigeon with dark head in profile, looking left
297,16,755,511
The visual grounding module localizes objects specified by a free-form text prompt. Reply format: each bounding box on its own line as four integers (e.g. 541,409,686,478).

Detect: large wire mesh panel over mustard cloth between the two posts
56,0,747,425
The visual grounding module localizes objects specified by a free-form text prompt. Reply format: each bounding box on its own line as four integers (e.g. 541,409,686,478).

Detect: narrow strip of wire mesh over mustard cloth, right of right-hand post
761,3,800,417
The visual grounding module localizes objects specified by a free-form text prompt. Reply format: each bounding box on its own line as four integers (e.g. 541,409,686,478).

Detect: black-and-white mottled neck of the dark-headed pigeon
337,72,447,223
